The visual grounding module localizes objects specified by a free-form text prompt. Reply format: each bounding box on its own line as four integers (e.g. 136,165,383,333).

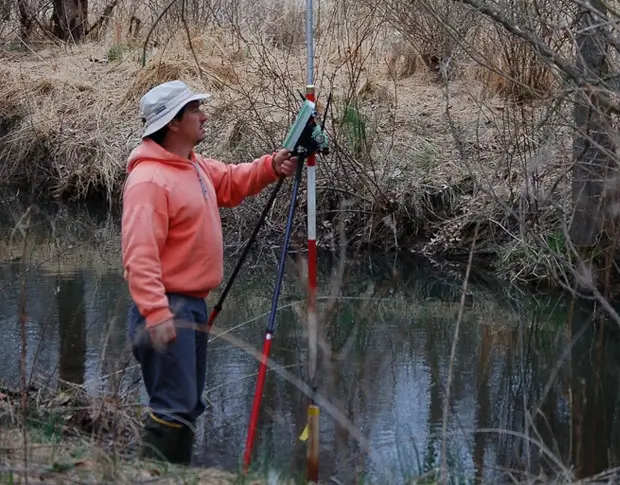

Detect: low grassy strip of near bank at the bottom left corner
0,389,272,485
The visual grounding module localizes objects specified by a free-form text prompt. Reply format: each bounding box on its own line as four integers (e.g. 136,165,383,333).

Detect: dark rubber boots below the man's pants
140,414,187,464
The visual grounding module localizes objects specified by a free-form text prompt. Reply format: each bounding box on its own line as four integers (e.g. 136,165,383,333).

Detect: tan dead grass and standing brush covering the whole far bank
0,0,584,286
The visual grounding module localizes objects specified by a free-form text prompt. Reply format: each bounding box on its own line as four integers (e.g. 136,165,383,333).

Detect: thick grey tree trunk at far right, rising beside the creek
570,0,613,247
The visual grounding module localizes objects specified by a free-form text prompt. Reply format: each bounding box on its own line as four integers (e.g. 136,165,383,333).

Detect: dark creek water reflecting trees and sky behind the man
0,201,620,483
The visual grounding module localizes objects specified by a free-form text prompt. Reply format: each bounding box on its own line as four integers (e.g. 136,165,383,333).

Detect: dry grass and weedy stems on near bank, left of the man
0,322,276,485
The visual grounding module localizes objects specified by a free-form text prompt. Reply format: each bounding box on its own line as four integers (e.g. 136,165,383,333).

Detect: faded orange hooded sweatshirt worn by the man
122,140,278,326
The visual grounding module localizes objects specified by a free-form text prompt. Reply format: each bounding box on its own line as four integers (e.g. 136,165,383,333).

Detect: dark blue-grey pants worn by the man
129,294,208,425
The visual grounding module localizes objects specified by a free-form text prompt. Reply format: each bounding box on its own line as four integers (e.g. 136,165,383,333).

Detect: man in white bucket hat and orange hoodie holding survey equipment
122,81,298,464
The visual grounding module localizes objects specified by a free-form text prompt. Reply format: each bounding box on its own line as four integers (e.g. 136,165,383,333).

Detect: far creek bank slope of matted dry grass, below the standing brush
0,26,570,285
